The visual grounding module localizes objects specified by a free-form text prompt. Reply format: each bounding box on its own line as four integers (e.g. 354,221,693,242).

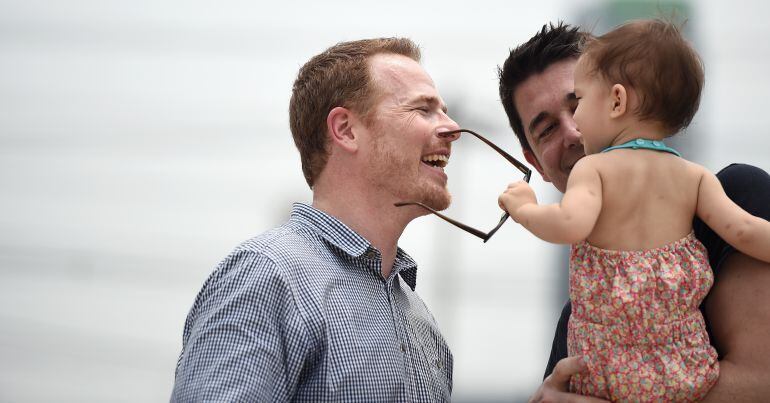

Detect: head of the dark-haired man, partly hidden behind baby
499,23,587,196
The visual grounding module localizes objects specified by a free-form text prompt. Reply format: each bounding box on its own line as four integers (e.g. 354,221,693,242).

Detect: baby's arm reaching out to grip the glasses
498,157,602,244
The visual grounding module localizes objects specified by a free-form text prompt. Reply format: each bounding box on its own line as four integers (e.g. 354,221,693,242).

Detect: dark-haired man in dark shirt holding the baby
499,23,770,402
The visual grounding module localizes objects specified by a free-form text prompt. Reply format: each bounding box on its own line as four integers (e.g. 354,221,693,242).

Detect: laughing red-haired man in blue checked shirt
171,38,458,402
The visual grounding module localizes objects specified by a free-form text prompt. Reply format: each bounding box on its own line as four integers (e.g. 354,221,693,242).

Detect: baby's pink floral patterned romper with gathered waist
567,233,719,402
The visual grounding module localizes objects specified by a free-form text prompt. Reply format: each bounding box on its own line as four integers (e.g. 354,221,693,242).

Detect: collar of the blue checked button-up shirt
291,203,417,291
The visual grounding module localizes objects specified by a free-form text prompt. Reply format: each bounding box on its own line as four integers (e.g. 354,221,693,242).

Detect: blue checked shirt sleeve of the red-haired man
171,251,311,402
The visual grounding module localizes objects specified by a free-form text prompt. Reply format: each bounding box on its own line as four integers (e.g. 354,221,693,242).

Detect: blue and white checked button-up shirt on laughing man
171,204,452,402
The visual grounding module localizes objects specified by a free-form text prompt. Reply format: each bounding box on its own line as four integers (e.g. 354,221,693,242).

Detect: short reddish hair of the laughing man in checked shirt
289,38,420,188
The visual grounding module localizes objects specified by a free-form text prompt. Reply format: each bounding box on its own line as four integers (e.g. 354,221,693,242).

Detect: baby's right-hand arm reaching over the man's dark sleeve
696,167,770,262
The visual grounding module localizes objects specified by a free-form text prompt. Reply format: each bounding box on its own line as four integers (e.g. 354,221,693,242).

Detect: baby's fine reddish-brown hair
581,19,704,135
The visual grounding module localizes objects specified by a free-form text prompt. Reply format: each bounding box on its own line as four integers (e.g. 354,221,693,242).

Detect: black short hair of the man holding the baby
497,21,589,150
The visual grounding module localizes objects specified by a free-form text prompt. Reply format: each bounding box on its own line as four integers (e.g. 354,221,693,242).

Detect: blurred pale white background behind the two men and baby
0,0,770,402
